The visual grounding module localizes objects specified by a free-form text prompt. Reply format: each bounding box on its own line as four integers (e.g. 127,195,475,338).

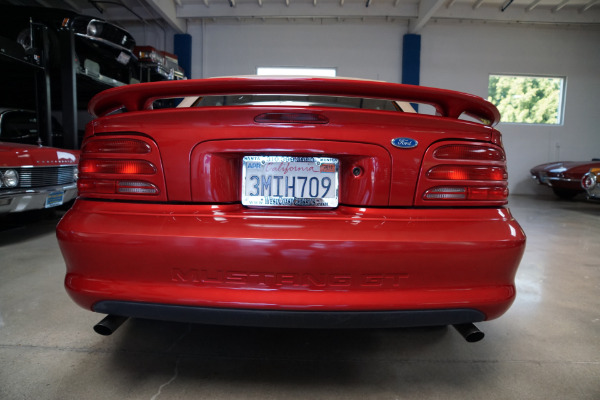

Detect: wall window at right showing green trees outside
488,75,565,125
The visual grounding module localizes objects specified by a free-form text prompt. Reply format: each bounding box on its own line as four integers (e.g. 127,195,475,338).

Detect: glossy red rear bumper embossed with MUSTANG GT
57,200,525,326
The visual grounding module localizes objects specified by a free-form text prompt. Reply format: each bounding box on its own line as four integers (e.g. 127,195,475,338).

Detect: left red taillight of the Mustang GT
78,136,166,201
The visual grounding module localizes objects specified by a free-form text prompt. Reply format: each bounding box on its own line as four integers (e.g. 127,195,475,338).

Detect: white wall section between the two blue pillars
188,20,407,82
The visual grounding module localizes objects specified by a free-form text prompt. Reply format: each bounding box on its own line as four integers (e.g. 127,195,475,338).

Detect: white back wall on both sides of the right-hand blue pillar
180,20,600,194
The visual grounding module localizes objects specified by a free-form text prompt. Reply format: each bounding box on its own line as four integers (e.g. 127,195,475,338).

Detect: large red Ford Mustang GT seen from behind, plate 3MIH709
57,77,525,341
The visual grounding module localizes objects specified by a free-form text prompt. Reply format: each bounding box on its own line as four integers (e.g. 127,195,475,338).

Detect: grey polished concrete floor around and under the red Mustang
0,197,600,400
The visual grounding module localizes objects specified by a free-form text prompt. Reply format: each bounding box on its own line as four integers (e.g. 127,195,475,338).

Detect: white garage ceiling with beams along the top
0,0,600,33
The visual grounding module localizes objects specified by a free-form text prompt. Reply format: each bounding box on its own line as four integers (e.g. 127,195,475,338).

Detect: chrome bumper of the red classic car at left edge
0,183,77,214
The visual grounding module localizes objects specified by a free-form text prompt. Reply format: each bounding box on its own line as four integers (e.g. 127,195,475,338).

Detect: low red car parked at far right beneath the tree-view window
530,159,600,199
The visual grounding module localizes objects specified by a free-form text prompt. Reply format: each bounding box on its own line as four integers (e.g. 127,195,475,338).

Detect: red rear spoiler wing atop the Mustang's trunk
88,76,500,126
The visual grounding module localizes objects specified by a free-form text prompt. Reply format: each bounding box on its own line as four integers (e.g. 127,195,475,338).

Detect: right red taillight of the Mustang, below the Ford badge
415,142,508,206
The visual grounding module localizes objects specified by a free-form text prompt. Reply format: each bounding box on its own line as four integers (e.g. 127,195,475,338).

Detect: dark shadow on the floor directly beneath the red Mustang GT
98,319,488,397
